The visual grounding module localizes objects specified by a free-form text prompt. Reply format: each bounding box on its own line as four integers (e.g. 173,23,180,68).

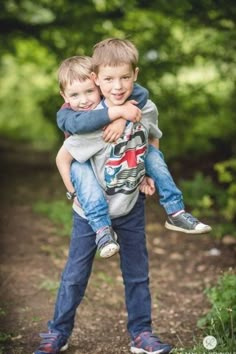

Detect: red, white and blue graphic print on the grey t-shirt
104,122,148,195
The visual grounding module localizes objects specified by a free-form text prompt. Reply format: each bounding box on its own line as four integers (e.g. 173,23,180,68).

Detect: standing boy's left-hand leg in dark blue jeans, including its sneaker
35,212,97,354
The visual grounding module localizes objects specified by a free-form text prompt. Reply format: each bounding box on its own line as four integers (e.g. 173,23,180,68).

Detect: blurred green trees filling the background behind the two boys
0,0,236,234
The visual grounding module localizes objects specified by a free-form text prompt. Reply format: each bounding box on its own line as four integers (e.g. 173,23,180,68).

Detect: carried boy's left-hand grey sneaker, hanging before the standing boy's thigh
96,226,120,258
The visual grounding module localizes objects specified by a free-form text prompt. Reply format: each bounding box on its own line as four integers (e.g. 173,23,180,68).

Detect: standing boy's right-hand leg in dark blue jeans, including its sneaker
113,194,171,354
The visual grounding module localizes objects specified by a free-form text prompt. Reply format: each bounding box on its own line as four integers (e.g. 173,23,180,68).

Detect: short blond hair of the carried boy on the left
57,56,93,92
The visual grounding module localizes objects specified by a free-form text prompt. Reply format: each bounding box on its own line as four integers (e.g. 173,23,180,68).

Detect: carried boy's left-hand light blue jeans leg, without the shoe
71,161,111,232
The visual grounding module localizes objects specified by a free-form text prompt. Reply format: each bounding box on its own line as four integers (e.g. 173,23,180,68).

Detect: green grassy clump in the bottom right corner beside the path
198,272,236,350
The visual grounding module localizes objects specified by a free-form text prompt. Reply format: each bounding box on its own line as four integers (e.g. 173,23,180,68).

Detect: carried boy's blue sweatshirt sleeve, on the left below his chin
57,107,111,134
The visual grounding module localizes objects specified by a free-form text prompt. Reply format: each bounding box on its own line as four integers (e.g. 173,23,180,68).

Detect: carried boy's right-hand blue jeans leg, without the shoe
145,144,184,215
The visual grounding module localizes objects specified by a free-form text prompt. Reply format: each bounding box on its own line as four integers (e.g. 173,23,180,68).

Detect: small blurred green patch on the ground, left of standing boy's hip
33,200,71,236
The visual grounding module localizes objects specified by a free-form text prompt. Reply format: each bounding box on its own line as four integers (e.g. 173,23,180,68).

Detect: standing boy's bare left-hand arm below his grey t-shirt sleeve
56,145,75,193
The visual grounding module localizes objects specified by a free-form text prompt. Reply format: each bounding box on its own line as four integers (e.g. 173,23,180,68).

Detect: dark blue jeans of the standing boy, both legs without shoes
49,194,151,339
